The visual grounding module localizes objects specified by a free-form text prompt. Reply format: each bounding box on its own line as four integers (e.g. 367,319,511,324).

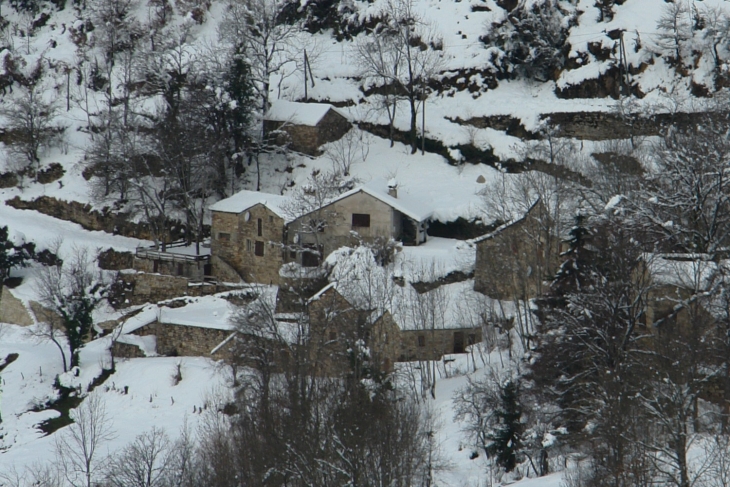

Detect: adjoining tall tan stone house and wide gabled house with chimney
210,181,432,284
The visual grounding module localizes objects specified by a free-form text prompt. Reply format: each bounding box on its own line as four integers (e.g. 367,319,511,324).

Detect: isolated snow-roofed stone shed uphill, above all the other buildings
264,100,351,156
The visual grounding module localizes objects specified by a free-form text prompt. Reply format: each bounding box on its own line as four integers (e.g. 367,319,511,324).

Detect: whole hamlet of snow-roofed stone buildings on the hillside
0,101,708,373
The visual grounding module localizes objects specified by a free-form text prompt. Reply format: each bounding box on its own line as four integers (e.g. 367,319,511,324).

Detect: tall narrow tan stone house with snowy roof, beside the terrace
210,191,289,285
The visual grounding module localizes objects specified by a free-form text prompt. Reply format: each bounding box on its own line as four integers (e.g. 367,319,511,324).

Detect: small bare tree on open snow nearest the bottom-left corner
56,394,115,487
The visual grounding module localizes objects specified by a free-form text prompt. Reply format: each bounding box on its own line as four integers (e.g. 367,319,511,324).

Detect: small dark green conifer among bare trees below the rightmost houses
487,380,525,472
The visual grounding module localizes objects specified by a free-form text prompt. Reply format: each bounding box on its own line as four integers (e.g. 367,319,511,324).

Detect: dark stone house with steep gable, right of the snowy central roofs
471,199,560,300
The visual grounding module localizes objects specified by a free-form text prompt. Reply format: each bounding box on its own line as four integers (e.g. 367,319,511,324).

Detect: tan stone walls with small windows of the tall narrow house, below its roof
211,204,284,284
